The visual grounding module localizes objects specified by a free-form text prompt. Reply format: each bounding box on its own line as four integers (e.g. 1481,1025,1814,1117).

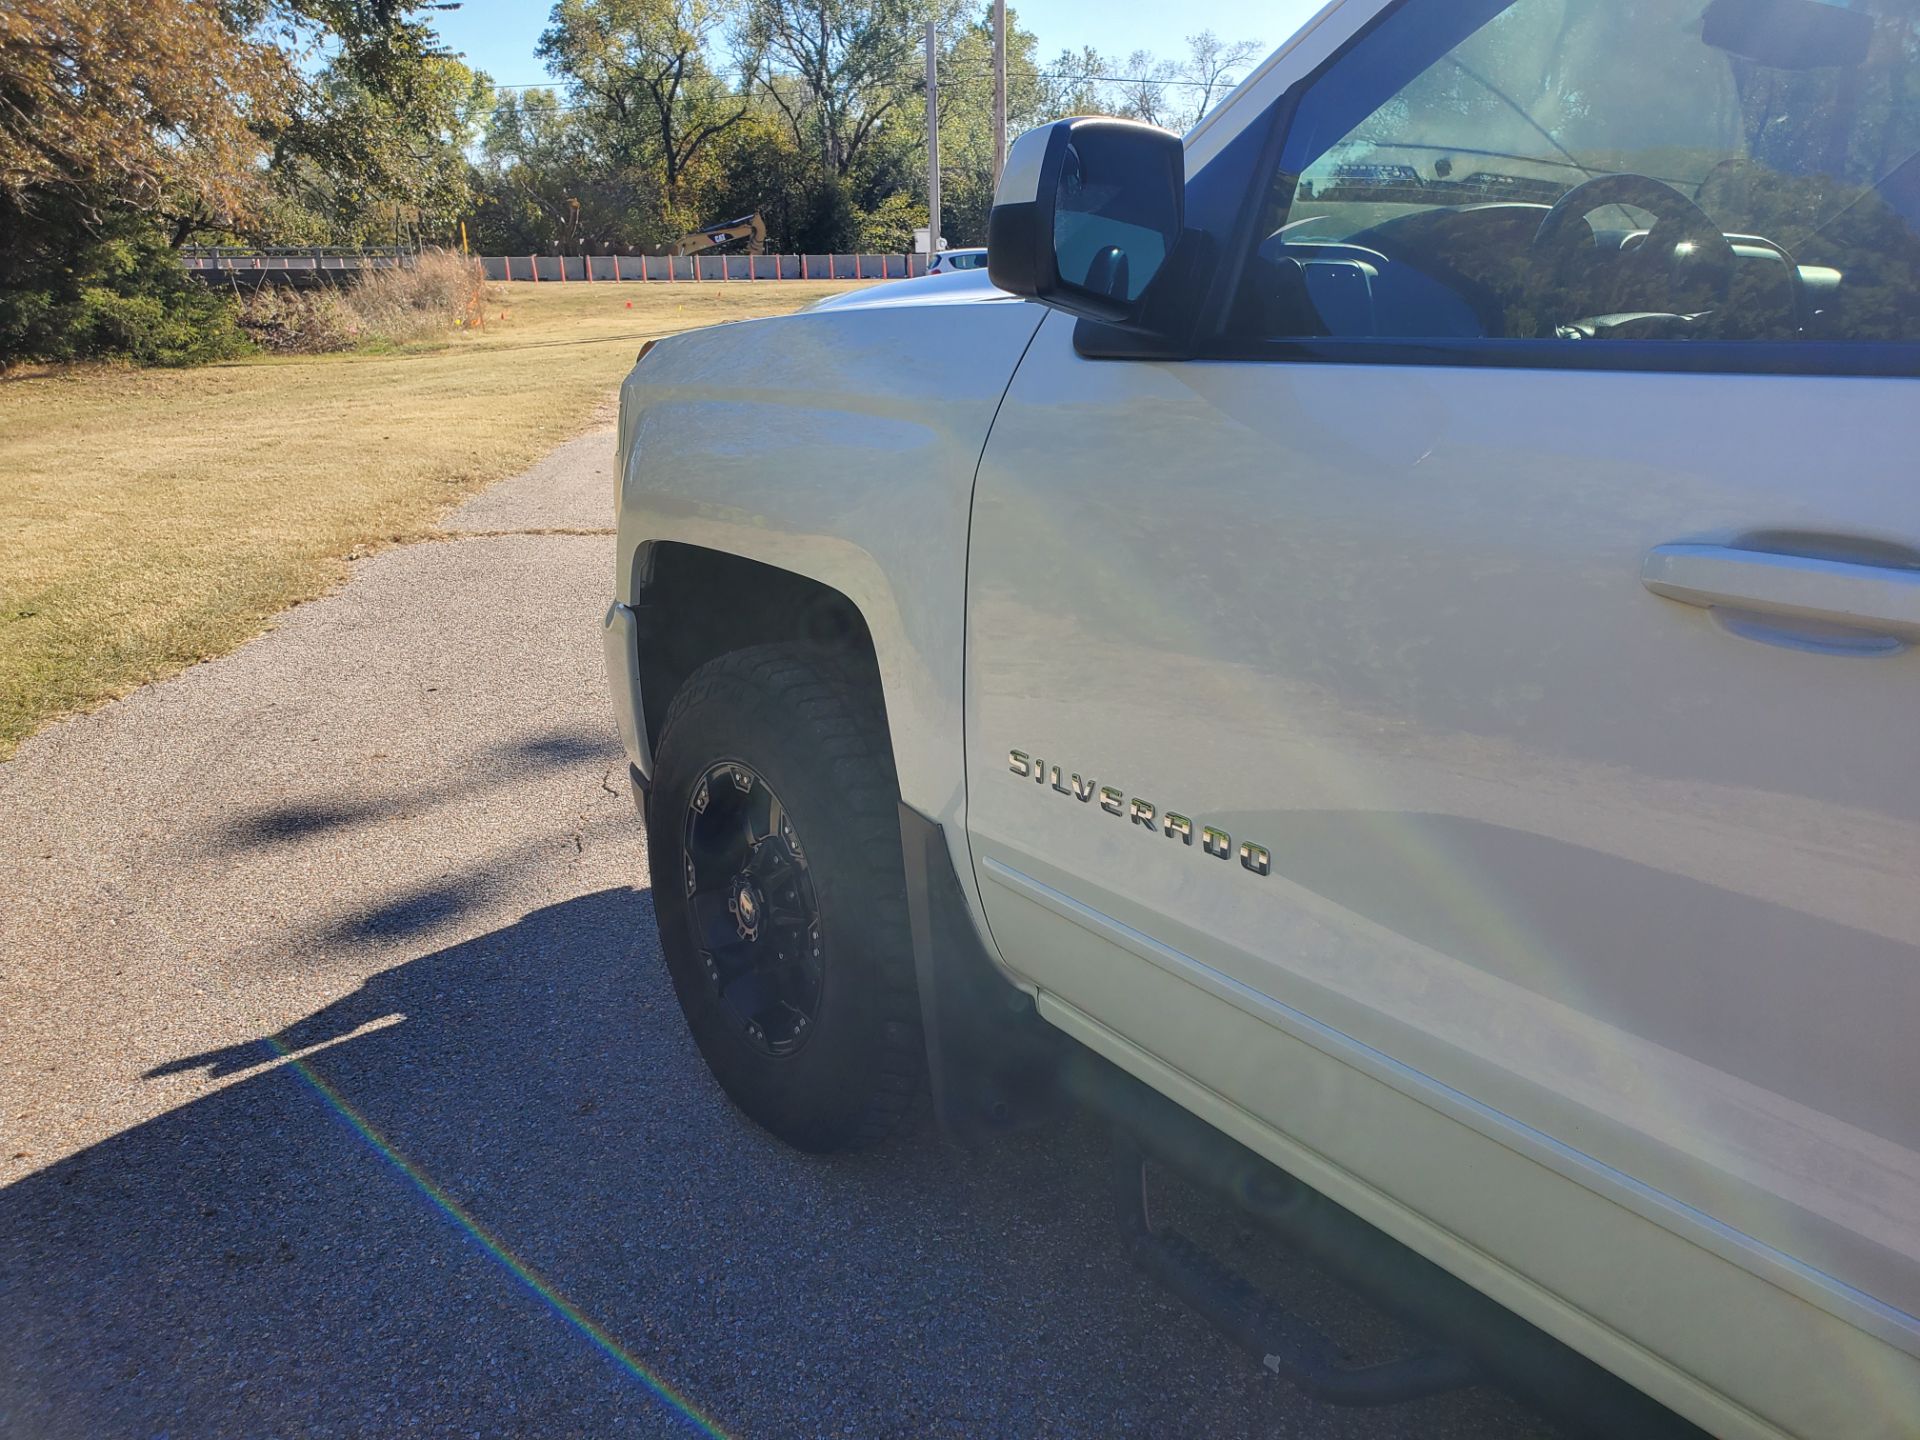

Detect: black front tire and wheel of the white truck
647,645,925,1152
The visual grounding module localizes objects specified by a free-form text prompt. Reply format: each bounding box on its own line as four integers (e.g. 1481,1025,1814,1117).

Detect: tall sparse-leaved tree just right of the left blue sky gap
540,0,747,216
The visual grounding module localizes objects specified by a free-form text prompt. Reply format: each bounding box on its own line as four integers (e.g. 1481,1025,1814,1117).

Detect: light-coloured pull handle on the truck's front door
1640,545,1920,639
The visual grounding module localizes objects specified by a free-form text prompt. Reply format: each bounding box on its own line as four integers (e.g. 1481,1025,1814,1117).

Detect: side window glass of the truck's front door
1231,0,1920,353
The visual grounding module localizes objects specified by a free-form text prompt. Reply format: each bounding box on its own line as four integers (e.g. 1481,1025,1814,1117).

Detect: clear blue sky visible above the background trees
434,0,1321,84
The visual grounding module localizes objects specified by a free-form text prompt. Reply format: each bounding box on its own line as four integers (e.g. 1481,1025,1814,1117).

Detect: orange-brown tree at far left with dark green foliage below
0,0,294,369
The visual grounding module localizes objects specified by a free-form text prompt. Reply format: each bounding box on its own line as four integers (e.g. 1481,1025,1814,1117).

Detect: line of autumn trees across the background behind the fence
0,0,1256,365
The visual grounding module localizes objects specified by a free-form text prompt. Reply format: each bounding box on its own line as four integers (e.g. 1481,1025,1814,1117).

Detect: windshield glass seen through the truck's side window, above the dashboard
1290,0,1920,261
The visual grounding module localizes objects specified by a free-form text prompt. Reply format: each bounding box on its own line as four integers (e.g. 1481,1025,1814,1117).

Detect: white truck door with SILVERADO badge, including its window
966,0,1920,1413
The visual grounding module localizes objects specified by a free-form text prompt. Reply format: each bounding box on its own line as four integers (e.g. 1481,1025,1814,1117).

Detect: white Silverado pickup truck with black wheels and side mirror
607,0,1920,1440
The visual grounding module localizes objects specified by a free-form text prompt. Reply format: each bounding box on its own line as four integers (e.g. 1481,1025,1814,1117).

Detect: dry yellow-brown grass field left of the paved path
0,282,871,758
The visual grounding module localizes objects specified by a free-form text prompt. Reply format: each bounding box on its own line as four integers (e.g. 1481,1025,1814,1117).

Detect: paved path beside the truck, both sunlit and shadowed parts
0,430,1548,1440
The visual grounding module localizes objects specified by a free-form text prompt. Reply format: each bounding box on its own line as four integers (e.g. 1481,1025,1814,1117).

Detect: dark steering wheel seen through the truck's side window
1530,175,1736,332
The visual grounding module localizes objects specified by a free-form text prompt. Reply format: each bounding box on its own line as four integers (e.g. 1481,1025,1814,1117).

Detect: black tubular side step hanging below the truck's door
1114,1131,1484,1405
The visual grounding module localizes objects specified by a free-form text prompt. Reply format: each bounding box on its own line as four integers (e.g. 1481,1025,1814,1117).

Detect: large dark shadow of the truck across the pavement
0,889,1559,1438
